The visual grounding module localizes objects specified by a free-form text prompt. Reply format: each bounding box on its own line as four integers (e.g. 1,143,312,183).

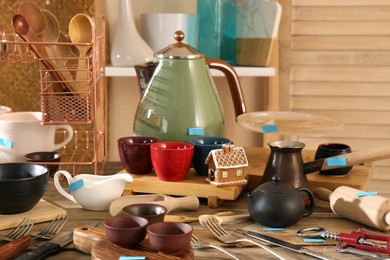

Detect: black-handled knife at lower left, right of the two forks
15,222,99,260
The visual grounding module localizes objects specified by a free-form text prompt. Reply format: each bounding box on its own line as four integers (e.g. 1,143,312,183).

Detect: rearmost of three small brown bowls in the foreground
121,203,167,225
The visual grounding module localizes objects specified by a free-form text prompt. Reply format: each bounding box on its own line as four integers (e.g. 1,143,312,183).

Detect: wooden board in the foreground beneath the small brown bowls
73,227,194,260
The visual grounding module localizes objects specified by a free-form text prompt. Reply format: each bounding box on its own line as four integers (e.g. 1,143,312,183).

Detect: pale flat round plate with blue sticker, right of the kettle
237,111,344,134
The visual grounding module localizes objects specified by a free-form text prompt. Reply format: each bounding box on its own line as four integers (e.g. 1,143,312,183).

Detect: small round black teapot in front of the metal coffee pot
248,175,315,228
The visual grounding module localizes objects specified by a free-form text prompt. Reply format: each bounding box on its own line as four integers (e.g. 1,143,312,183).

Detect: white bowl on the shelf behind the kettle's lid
141,13,197,52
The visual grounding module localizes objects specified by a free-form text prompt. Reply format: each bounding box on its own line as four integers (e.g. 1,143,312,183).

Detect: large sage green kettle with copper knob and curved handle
133,31,246,142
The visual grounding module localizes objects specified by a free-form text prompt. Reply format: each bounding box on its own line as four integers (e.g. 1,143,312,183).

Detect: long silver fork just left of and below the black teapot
199,215,294,259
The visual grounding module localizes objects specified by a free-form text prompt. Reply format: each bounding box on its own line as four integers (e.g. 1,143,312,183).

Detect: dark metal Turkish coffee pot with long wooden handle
262,140,390,189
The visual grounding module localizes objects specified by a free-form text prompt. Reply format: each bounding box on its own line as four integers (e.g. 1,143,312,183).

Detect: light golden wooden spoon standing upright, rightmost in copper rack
69,13,93,92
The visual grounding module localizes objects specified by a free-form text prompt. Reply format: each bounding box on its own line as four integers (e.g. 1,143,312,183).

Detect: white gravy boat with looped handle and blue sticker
54,170,133,211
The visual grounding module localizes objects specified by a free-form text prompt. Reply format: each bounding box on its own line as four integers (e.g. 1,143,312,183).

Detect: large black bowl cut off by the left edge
0,163,49,214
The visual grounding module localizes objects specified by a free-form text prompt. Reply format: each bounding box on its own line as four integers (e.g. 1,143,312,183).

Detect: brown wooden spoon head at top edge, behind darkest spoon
19,1,46,36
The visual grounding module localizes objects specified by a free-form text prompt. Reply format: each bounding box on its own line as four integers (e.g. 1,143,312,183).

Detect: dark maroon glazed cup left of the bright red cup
118,136,158,174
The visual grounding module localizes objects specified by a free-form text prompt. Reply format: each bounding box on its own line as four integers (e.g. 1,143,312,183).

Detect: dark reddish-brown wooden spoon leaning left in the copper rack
12,14,74,92
